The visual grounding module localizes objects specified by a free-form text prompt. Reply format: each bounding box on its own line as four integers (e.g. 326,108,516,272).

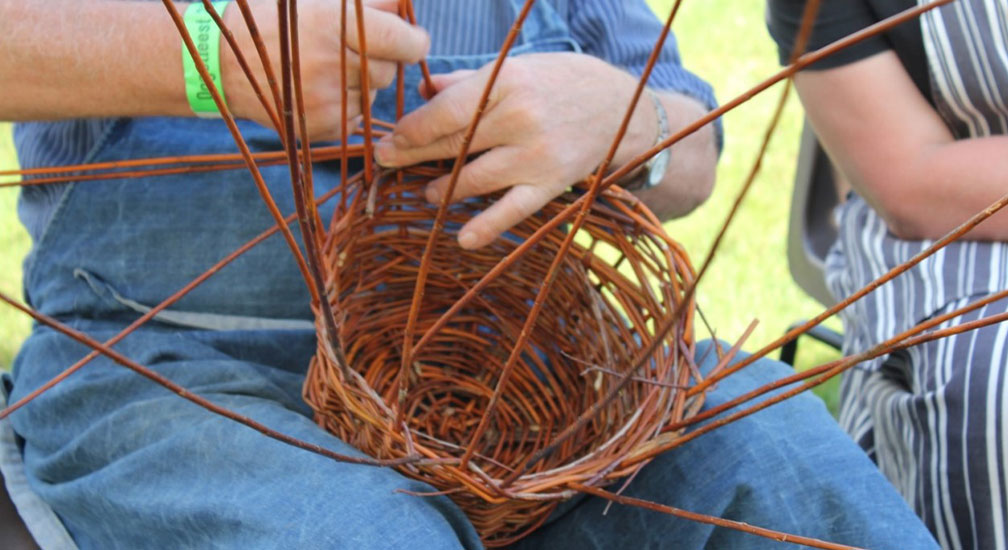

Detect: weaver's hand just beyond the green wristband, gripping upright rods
221,0,429,140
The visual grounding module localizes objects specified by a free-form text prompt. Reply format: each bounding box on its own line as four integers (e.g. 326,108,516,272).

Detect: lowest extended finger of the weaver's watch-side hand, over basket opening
459,184,553,249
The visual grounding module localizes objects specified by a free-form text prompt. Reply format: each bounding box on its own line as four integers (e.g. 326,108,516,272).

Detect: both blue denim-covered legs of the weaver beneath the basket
5,321,936,549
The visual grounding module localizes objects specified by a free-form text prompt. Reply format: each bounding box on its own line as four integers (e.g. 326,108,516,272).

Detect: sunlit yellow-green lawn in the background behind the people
0,0,837,402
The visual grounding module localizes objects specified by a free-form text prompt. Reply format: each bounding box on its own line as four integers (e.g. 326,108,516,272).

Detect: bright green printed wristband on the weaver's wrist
182,2,228,118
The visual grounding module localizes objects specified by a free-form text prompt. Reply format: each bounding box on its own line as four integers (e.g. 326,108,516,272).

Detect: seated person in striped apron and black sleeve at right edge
767,0,1008,549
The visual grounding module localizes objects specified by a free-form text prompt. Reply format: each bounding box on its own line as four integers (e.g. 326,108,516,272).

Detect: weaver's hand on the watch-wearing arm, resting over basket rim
375,53,658,248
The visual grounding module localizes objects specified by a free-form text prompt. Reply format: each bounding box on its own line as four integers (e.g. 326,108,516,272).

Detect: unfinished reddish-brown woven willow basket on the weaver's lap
304,168,699,546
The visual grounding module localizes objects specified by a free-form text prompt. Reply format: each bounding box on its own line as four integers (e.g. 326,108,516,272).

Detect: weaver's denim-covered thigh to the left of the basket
12,320,479,548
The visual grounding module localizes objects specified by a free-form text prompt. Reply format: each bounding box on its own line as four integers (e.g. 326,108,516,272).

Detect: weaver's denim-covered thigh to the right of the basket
519,338,934,549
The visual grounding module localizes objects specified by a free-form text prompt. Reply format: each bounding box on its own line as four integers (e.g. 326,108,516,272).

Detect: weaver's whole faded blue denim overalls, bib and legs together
5,0,933,549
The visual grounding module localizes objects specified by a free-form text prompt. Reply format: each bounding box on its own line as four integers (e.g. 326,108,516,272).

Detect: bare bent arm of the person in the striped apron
794,51,1008,241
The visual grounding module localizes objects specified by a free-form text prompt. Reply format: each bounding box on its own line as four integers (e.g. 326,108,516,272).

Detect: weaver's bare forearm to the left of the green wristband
0,0,192,120
